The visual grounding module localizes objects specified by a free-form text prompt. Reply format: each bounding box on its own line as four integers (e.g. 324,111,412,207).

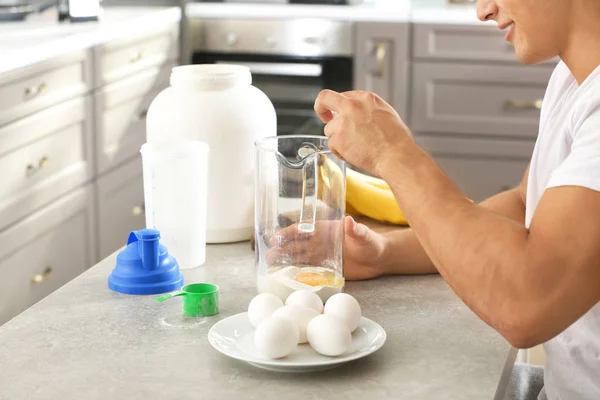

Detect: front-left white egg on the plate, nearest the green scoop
254,316,300,359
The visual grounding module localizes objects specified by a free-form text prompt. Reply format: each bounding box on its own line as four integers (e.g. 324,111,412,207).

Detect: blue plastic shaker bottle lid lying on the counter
108,229,183,295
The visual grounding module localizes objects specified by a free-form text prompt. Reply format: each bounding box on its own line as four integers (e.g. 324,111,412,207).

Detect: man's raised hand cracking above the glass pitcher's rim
315,90,414,175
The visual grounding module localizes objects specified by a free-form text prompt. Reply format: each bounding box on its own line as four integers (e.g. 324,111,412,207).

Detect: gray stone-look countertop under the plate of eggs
0,243,516,400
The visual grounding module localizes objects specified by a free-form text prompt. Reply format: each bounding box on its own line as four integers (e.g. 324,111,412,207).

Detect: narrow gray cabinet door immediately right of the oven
354,22,410,118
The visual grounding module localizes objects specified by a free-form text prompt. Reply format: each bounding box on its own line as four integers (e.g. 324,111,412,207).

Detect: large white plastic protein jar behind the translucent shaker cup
146,64,277,243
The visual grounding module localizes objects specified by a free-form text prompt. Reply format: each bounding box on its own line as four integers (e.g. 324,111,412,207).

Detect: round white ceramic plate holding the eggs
208,313,386,372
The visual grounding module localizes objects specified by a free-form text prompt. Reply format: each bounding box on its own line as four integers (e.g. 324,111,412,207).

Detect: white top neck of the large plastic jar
170,64,252,90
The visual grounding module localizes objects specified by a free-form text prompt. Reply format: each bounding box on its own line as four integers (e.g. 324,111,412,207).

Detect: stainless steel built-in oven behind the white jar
191,19,354,140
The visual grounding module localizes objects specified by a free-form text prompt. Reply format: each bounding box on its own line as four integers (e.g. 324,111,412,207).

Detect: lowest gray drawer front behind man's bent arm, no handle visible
415,134,535,202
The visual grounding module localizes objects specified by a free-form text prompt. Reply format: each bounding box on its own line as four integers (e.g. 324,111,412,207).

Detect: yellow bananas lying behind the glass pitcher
318,156,408,225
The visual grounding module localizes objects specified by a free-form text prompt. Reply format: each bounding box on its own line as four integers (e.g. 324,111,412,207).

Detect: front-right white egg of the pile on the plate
306,314,352,357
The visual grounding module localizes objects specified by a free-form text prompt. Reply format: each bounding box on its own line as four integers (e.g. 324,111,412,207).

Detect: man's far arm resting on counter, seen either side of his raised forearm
383,177,525,275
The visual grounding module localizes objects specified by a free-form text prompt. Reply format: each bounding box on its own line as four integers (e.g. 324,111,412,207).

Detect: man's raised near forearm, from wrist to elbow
380,145,537,346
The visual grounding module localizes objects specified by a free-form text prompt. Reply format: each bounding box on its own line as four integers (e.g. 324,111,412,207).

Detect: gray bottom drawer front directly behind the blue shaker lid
97,156,146,259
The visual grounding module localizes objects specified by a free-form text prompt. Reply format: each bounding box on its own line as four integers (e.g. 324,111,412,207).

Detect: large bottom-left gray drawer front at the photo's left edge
0,186,96,325
